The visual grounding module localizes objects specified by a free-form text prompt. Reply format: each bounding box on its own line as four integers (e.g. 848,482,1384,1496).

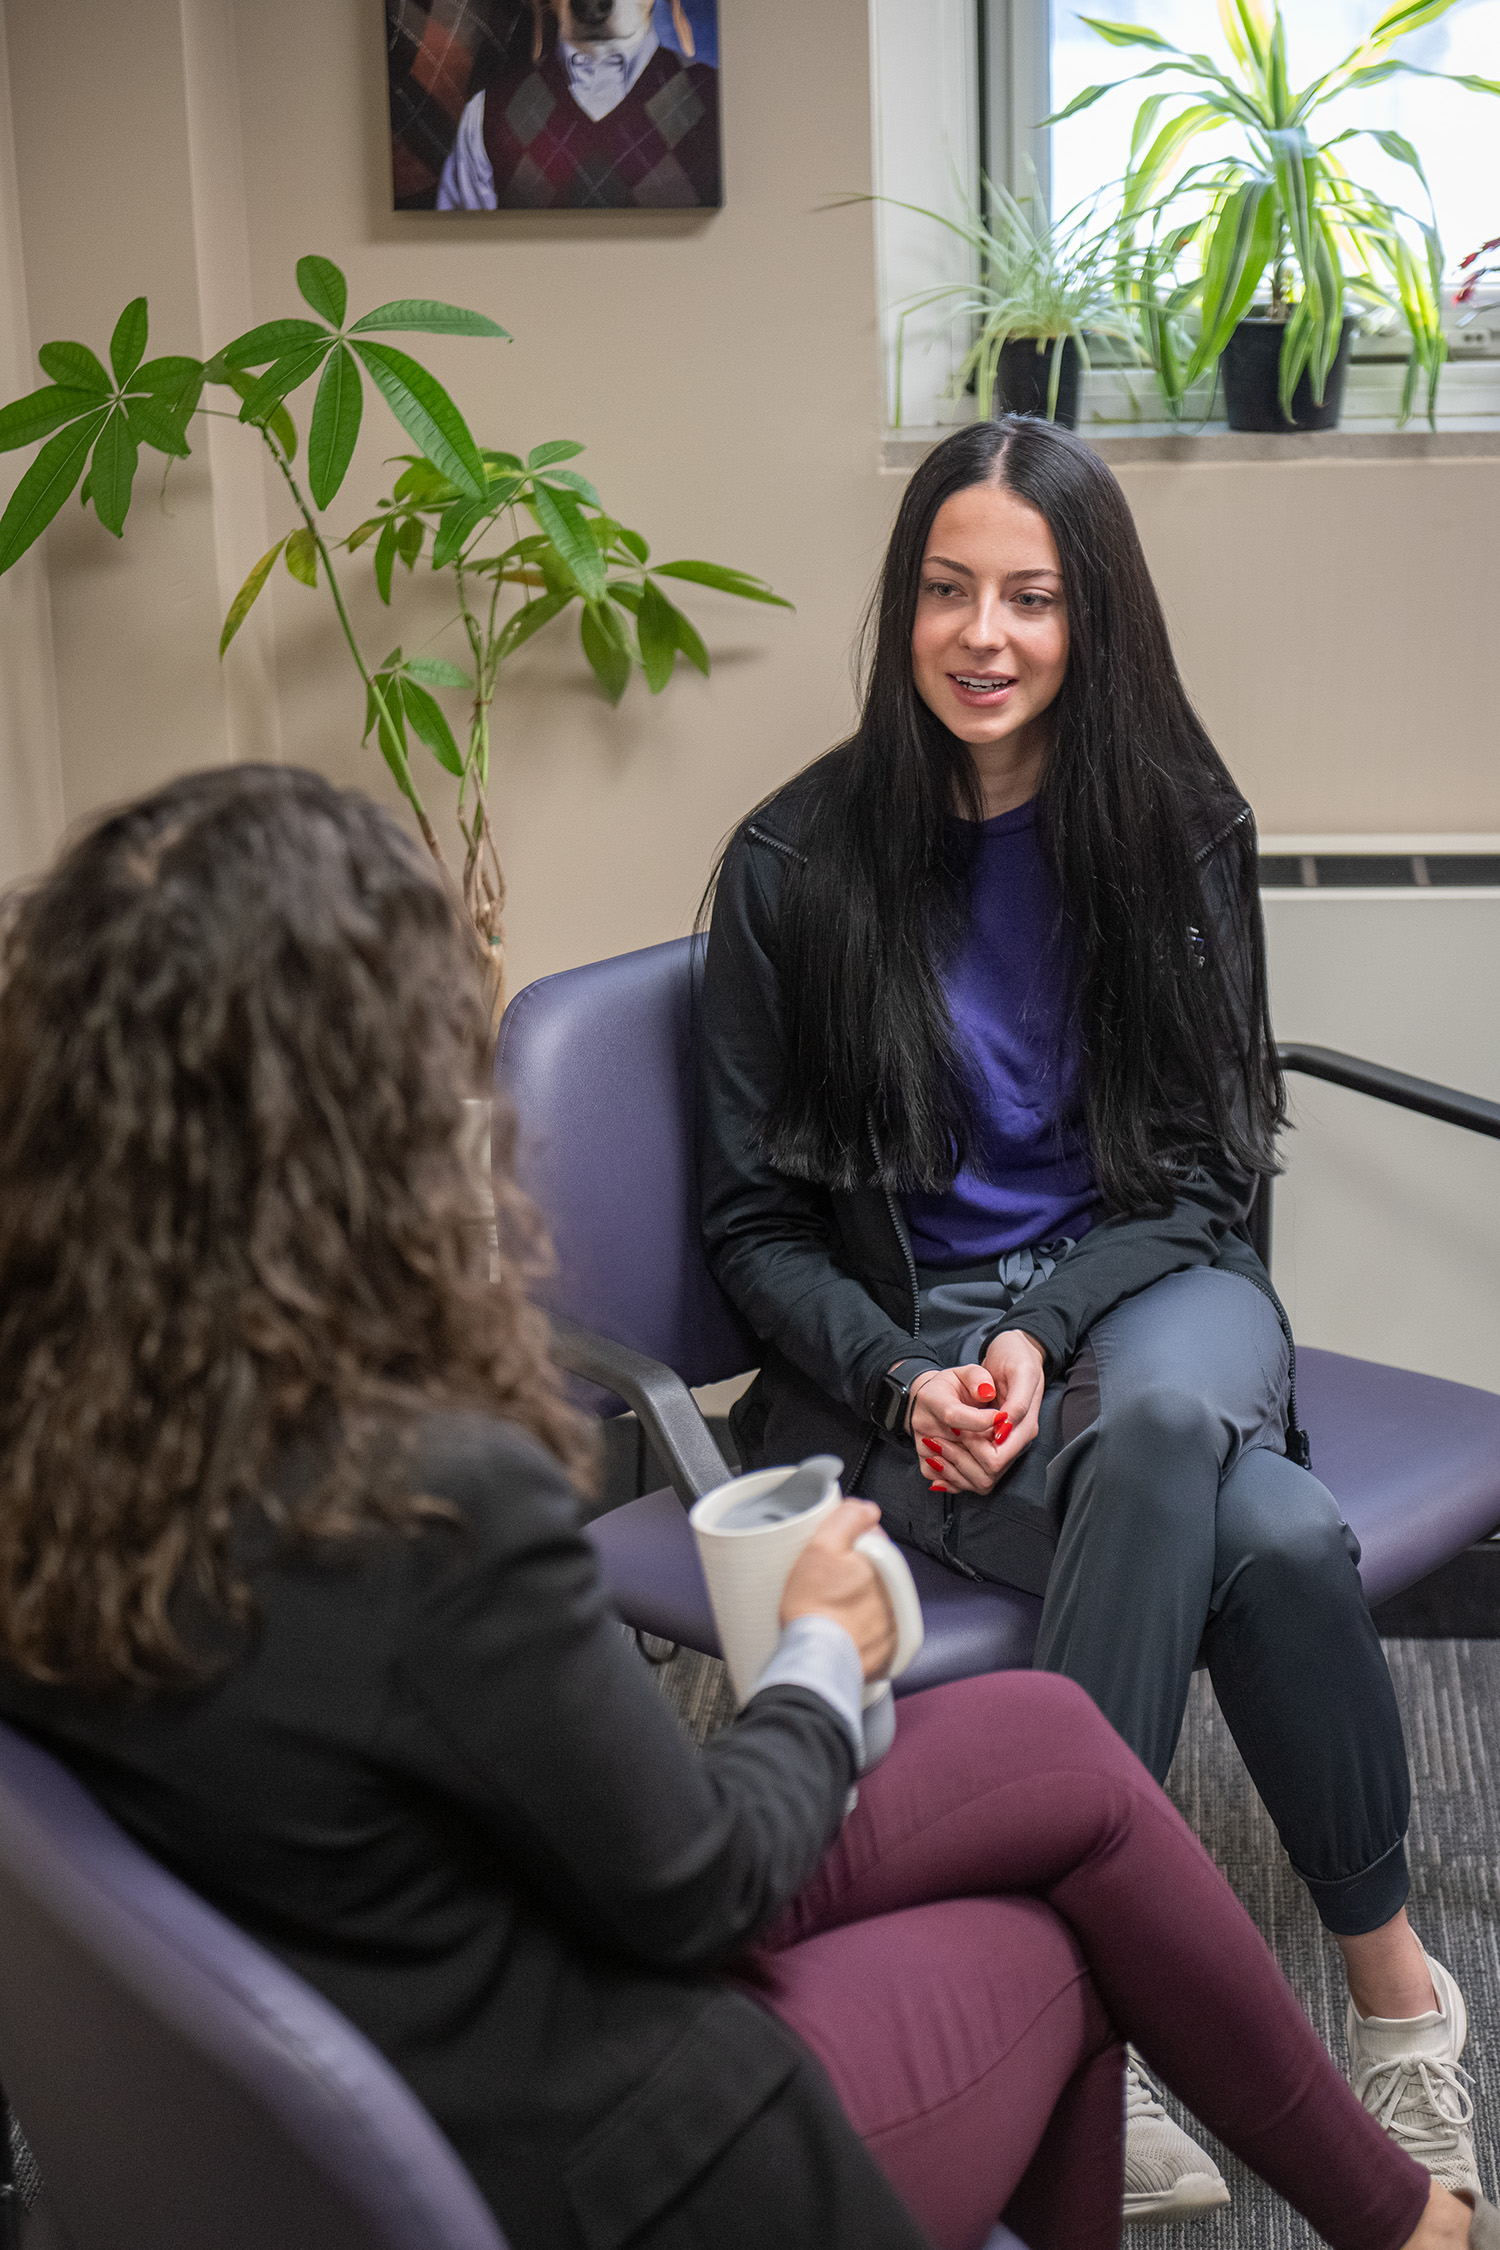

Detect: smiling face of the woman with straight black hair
911,484,1068,752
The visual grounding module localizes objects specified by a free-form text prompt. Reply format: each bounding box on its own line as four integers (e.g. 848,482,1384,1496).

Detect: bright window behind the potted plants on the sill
870,0,1500,430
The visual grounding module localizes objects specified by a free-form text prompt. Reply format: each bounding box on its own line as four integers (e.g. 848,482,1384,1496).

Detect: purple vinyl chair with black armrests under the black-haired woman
495,938,1500,1694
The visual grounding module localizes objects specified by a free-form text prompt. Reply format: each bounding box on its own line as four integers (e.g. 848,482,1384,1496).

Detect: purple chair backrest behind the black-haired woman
495,938,760,1384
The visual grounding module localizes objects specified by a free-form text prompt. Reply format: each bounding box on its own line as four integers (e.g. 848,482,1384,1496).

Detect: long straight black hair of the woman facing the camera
767,416,1284,1213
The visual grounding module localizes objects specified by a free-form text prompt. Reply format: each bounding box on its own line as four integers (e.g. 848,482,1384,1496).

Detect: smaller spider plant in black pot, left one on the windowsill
868,178,1138,430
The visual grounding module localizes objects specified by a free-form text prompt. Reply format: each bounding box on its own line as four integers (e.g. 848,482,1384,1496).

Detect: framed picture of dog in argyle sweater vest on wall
385,0,724,212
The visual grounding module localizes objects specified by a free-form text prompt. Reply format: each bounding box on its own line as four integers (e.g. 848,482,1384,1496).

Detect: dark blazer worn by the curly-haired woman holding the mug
0,1415,922,2250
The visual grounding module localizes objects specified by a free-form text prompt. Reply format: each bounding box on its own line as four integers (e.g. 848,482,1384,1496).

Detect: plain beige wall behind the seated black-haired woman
0,0,1500,981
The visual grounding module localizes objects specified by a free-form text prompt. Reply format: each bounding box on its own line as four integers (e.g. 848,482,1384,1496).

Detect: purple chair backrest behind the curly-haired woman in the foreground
0,1726,506,2250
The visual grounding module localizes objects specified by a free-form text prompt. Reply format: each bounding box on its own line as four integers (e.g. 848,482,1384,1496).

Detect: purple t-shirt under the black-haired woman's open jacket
902,801,1097,1267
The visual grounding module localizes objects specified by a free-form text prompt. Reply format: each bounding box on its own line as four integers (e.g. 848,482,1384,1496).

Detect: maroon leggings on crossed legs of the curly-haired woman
740,1672,1430,2250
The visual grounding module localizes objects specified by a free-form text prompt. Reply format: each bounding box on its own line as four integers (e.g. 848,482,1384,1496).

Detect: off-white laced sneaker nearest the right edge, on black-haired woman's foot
1345,1953,1480,2196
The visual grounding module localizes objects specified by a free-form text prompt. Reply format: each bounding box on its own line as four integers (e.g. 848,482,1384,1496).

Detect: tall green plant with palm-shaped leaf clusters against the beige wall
0,257,789,1008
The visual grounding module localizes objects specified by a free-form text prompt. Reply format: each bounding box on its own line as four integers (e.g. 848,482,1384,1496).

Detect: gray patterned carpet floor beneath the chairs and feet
657,1640,1500,2250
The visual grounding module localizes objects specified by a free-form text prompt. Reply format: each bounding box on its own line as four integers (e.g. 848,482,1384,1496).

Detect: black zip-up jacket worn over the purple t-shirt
697,765,1302,1584
